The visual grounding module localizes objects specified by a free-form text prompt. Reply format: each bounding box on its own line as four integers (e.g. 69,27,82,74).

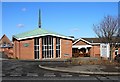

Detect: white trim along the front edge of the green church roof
14,34,74,40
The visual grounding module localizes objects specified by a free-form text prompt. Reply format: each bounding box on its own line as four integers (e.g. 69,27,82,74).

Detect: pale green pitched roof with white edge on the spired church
13,28,73,40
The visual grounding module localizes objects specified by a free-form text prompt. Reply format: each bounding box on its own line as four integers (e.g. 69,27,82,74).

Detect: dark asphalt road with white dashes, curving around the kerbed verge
1,60,120,82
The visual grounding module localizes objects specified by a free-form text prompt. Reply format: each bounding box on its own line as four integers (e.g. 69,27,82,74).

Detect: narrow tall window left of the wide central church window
34,38,40,59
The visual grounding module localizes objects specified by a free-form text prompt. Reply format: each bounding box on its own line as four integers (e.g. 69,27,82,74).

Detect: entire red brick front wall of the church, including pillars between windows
14,38,72,59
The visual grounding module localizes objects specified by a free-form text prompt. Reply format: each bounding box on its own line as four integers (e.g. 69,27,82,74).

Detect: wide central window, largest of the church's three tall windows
42,36,53,58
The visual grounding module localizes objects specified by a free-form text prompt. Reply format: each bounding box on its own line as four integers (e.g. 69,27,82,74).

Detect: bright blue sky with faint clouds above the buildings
0,2,118,40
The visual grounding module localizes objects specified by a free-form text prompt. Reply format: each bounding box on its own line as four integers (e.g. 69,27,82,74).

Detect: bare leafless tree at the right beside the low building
93,15,120,60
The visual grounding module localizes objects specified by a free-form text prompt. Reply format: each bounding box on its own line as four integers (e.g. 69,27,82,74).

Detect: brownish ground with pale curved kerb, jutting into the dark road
39,65,120,75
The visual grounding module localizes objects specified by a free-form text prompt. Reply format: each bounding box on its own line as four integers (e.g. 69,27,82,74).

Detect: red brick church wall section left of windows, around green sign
14,39,34,59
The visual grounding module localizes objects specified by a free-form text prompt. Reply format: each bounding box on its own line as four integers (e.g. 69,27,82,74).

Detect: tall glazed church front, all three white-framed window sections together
34,36,60,59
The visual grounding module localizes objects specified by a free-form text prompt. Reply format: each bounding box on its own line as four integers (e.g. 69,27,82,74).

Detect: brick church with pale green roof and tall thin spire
12,11,73,60
